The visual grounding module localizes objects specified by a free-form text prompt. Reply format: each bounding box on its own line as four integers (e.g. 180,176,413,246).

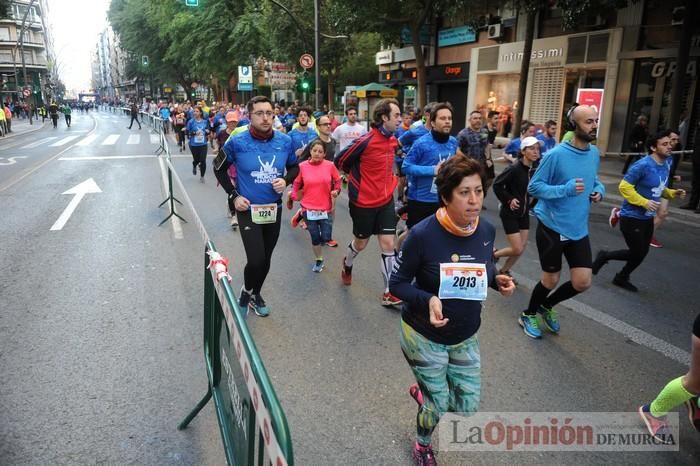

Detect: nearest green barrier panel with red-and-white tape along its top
178,241,294,466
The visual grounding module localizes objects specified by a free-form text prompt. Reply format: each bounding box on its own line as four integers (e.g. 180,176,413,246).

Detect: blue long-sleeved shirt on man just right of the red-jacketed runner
401,133,457,204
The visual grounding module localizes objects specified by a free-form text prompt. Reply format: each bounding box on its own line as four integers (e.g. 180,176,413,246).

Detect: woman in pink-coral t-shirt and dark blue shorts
291,137,340,273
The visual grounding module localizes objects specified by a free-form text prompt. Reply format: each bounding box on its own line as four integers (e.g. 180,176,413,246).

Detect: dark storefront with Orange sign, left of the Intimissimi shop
426,62,469,135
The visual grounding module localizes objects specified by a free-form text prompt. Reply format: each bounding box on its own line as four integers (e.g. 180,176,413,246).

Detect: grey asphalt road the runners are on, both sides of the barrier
0,113,700,465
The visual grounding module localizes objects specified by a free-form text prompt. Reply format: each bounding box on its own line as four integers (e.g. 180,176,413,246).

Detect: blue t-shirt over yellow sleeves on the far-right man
620,155,673,220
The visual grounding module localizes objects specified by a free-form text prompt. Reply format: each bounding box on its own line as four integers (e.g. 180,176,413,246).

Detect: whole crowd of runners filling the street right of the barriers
130,96,700,465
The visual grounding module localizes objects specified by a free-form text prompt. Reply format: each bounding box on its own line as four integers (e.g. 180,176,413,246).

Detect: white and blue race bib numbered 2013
438,262,488,301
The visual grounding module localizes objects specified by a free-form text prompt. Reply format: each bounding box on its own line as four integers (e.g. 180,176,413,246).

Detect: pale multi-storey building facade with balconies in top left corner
0,0,58,105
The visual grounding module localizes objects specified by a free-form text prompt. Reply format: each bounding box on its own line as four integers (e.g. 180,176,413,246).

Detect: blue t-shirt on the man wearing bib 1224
224,131,298,204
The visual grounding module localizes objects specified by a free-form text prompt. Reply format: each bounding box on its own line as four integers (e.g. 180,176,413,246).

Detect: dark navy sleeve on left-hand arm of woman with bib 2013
389,232,433,310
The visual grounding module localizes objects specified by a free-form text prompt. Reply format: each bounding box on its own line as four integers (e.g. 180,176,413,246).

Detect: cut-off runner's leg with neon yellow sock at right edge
638,314,700,443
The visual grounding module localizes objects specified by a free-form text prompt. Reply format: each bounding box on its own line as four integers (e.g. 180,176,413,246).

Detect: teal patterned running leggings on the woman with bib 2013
401,320,481,445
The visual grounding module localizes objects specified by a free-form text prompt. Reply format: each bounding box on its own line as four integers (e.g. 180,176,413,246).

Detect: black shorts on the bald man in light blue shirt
536,222,593,273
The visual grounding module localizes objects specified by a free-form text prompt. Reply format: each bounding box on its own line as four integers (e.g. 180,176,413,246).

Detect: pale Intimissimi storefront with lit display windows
467,29,622,150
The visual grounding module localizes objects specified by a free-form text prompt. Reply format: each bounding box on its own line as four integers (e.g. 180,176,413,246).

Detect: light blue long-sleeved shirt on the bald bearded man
527,142,605,240
